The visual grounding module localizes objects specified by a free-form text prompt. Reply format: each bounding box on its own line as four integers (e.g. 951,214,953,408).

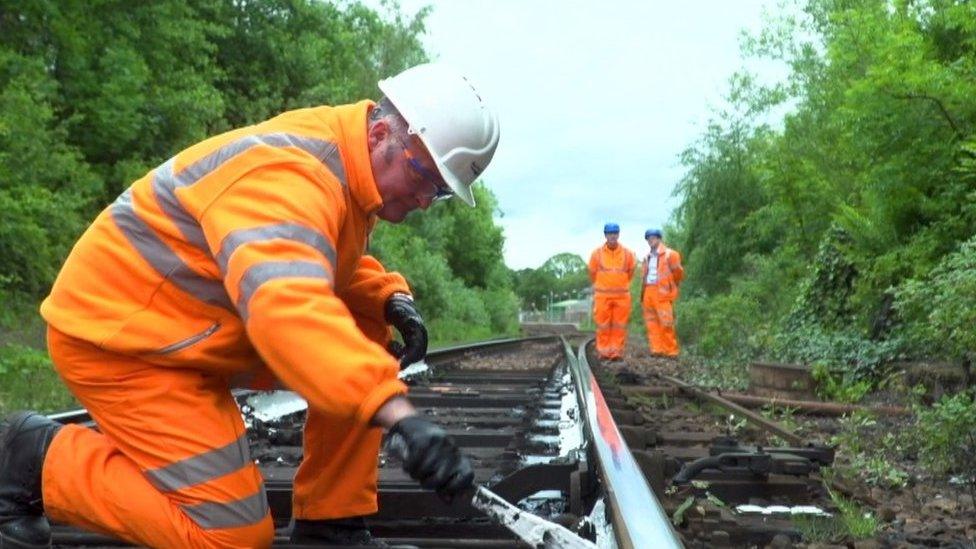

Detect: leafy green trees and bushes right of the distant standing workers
670,0,976,391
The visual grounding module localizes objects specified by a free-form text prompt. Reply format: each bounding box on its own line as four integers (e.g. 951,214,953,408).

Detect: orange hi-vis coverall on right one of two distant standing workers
641,244,685,356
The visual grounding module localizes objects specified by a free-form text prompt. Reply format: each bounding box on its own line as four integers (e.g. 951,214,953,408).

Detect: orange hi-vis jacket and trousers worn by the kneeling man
41,101,408,548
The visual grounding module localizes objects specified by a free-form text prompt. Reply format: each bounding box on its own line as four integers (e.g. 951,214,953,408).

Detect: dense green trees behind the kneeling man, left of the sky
0,0,517,352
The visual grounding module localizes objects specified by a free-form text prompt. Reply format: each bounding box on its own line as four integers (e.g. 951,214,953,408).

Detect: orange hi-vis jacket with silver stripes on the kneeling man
41,101,409,422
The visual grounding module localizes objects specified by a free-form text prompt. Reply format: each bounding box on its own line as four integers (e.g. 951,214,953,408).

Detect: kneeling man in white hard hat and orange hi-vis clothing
0,63,498,549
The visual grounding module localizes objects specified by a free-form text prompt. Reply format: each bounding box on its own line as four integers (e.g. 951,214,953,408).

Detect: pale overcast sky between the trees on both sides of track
378,0,785,269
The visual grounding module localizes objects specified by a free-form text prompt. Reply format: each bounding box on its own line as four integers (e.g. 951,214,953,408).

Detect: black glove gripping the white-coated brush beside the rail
388,416,474,501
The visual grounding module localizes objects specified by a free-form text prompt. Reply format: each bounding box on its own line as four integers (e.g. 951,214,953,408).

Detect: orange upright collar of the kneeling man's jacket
320,100,383,216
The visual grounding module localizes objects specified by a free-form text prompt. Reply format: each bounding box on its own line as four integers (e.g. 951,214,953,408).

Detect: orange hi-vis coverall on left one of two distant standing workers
589,243,637,359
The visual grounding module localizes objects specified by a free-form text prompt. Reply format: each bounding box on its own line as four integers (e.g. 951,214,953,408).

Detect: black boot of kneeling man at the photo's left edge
0,412,61,549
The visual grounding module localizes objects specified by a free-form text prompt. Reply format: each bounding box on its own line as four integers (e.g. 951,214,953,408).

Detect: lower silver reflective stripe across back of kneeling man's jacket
112,188,232,310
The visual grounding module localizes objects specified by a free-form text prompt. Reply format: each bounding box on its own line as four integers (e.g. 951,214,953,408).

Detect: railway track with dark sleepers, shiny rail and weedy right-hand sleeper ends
43,336,833,548
